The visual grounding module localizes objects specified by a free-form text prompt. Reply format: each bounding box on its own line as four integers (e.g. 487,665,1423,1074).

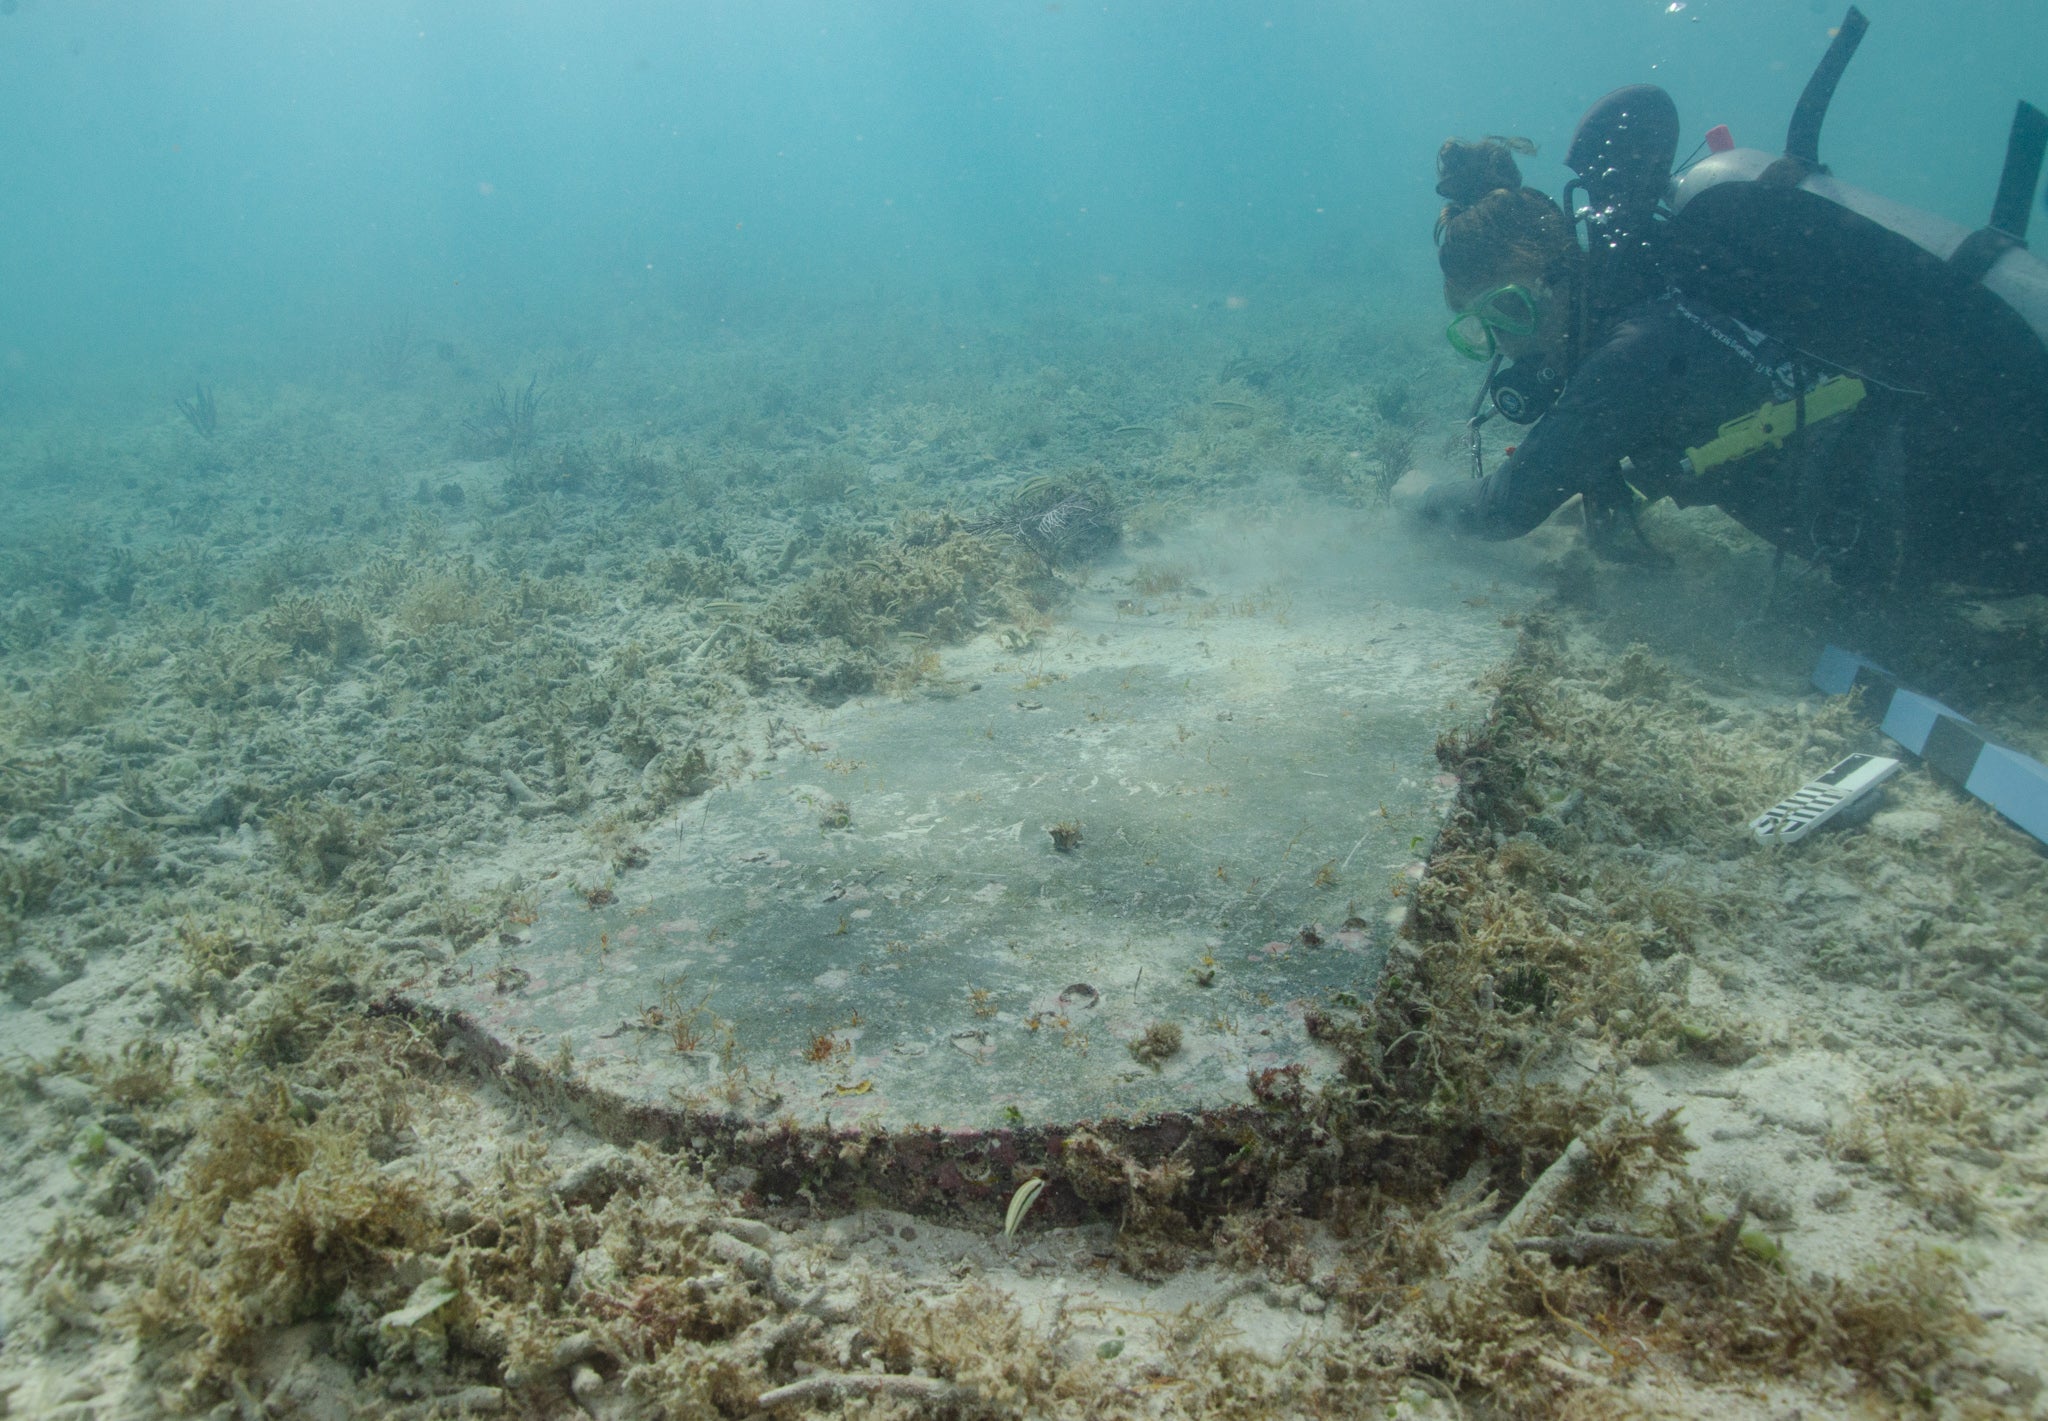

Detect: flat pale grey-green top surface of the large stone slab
416,518,1505,1132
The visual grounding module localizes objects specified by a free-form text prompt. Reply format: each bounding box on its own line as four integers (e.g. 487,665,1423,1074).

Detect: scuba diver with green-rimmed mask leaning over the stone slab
1415,8,2048,592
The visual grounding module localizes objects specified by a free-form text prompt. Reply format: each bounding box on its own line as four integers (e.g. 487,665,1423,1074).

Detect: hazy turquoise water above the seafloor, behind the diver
0,0,2048,387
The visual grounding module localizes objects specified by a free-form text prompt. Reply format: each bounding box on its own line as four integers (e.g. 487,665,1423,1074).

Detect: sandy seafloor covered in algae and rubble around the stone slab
0,289,2048,1419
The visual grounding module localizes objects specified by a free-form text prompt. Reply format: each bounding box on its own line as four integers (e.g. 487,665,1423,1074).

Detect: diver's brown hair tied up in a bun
1436,135,1579,289
